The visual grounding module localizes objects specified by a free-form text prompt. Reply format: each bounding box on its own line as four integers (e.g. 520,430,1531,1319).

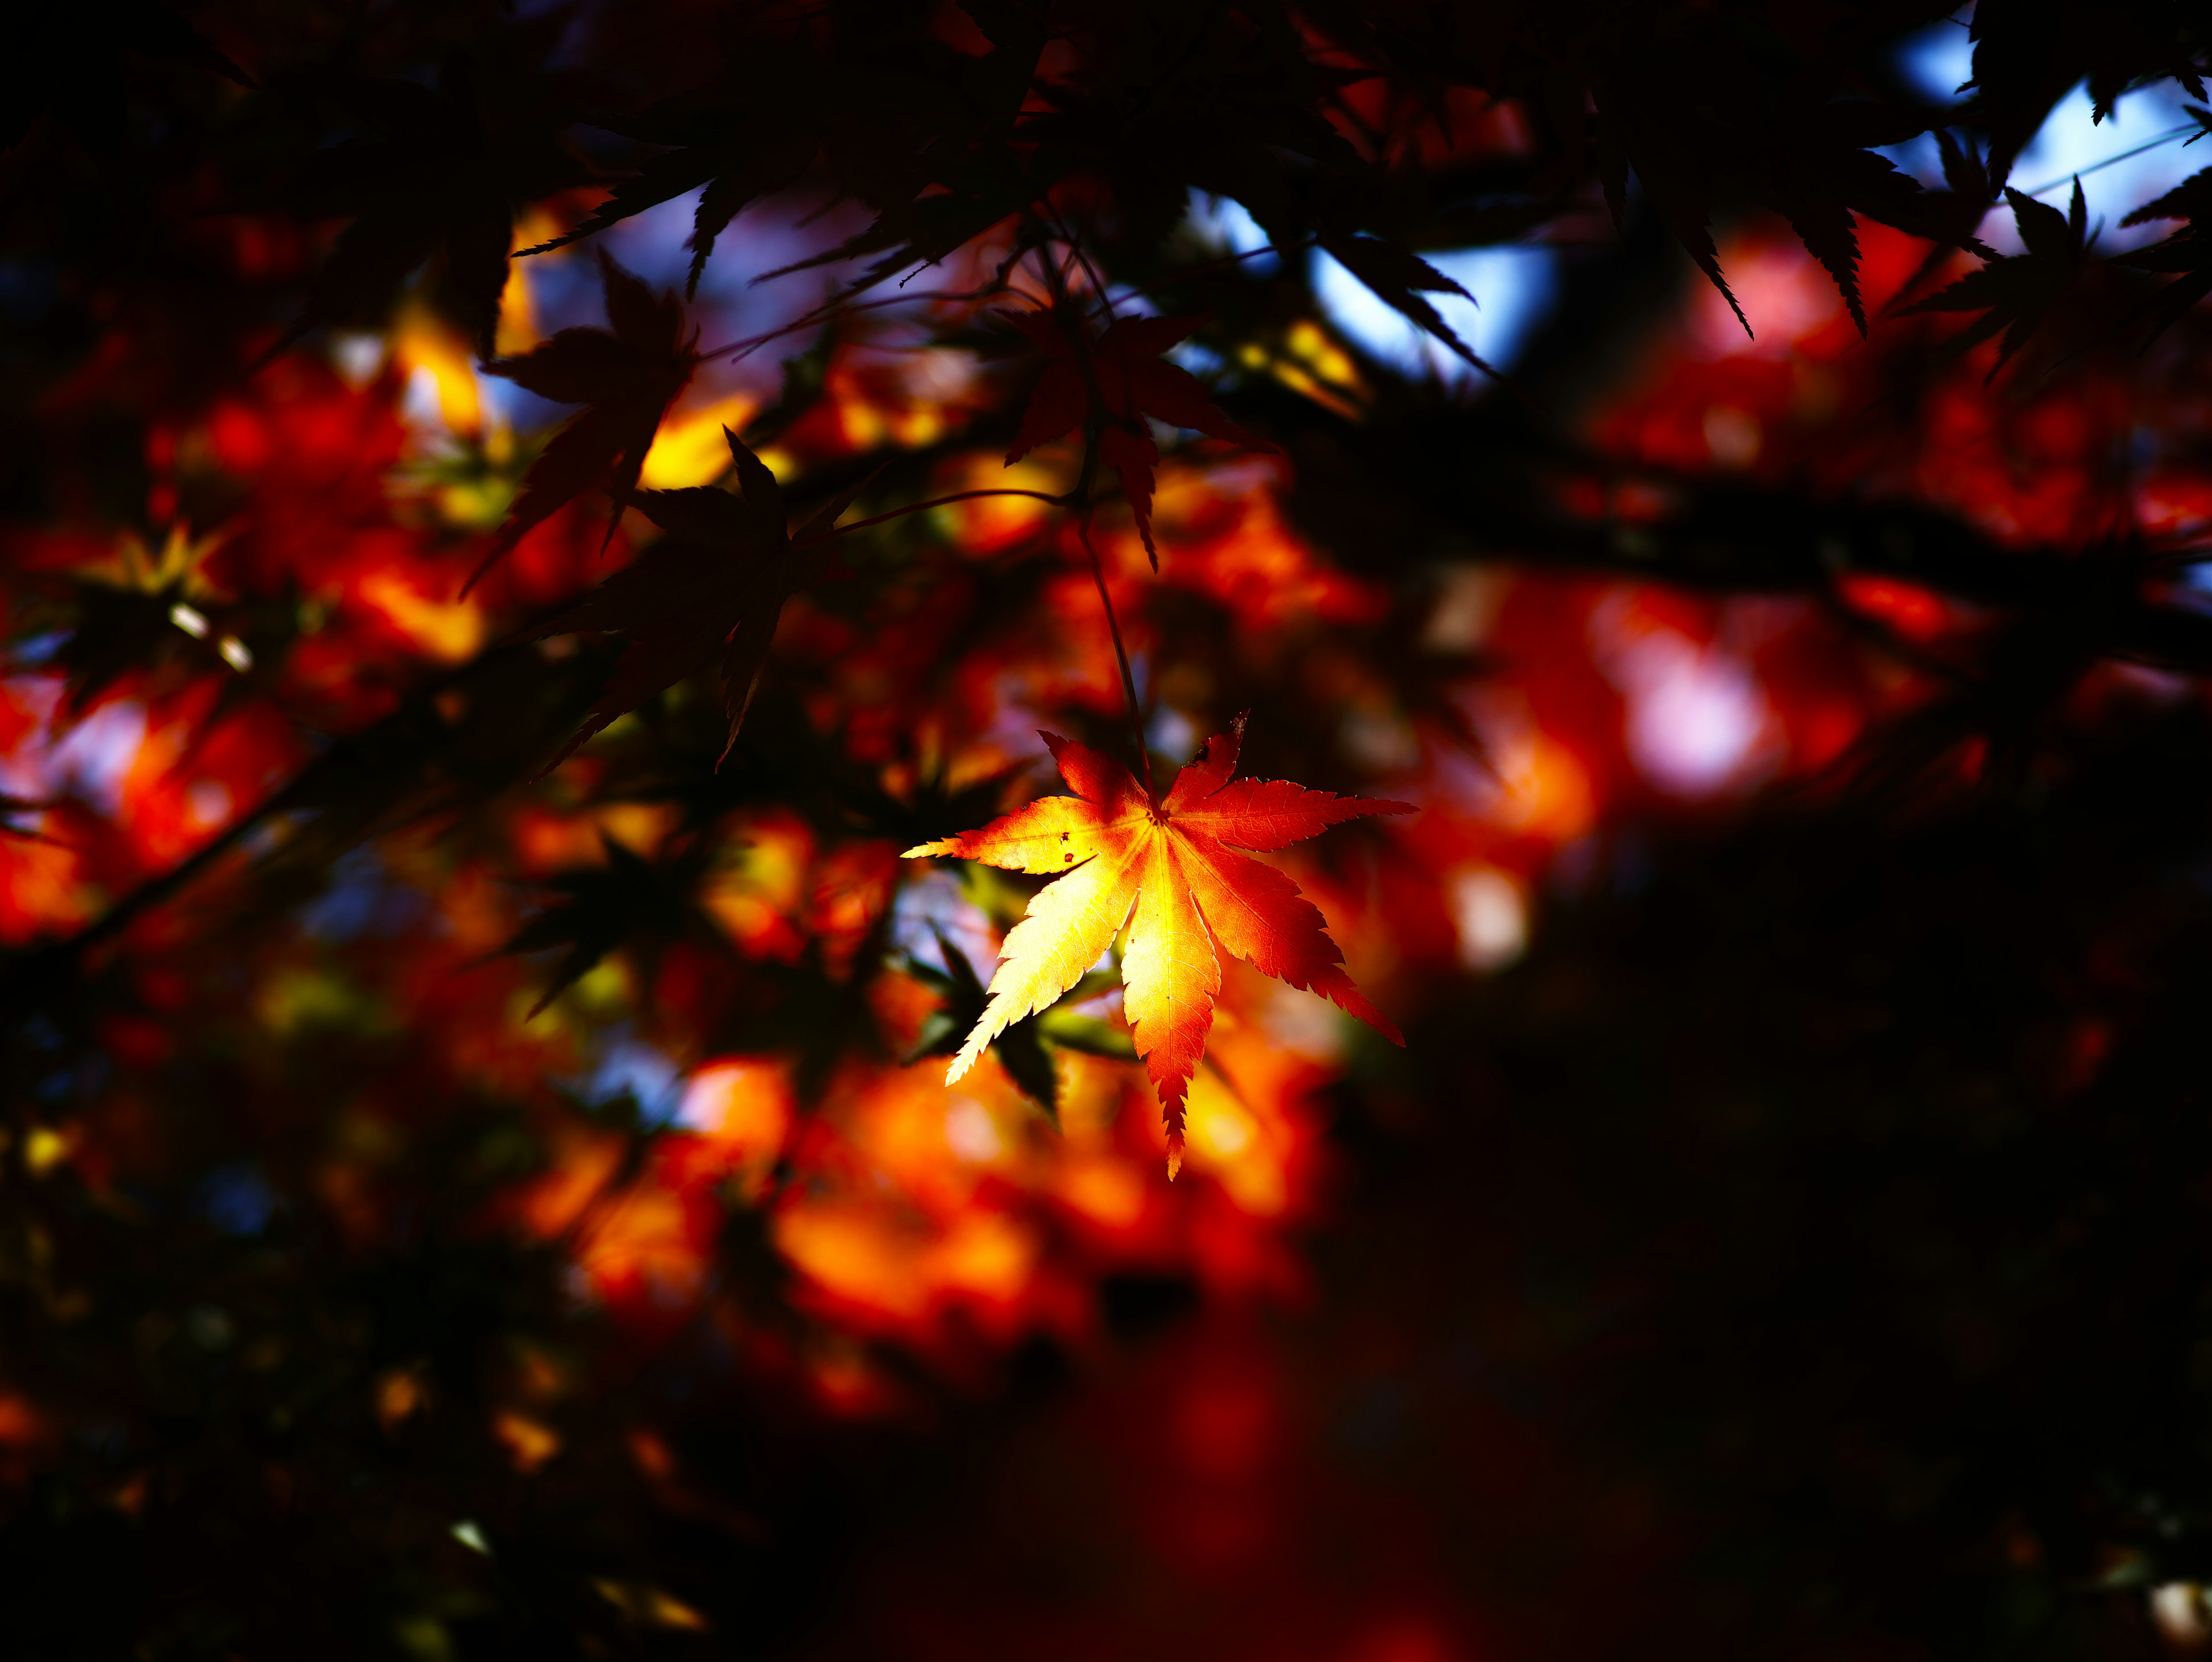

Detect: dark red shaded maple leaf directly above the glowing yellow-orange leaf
1000,312,1279,571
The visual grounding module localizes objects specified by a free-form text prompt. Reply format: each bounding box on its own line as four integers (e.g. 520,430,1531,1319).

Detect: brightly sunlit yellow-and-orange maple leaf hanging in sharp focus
905,717,1414,1175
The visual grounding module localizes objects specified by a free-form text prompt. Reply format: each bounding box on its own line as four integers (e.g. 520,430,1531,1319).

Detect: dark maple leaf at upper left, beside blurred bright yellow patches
475,248,699,593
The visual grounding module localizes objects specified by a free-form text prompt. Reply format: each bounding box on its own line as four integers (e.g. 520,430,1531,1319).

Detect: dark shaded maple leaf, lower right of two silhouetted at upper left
522,427,867,773
